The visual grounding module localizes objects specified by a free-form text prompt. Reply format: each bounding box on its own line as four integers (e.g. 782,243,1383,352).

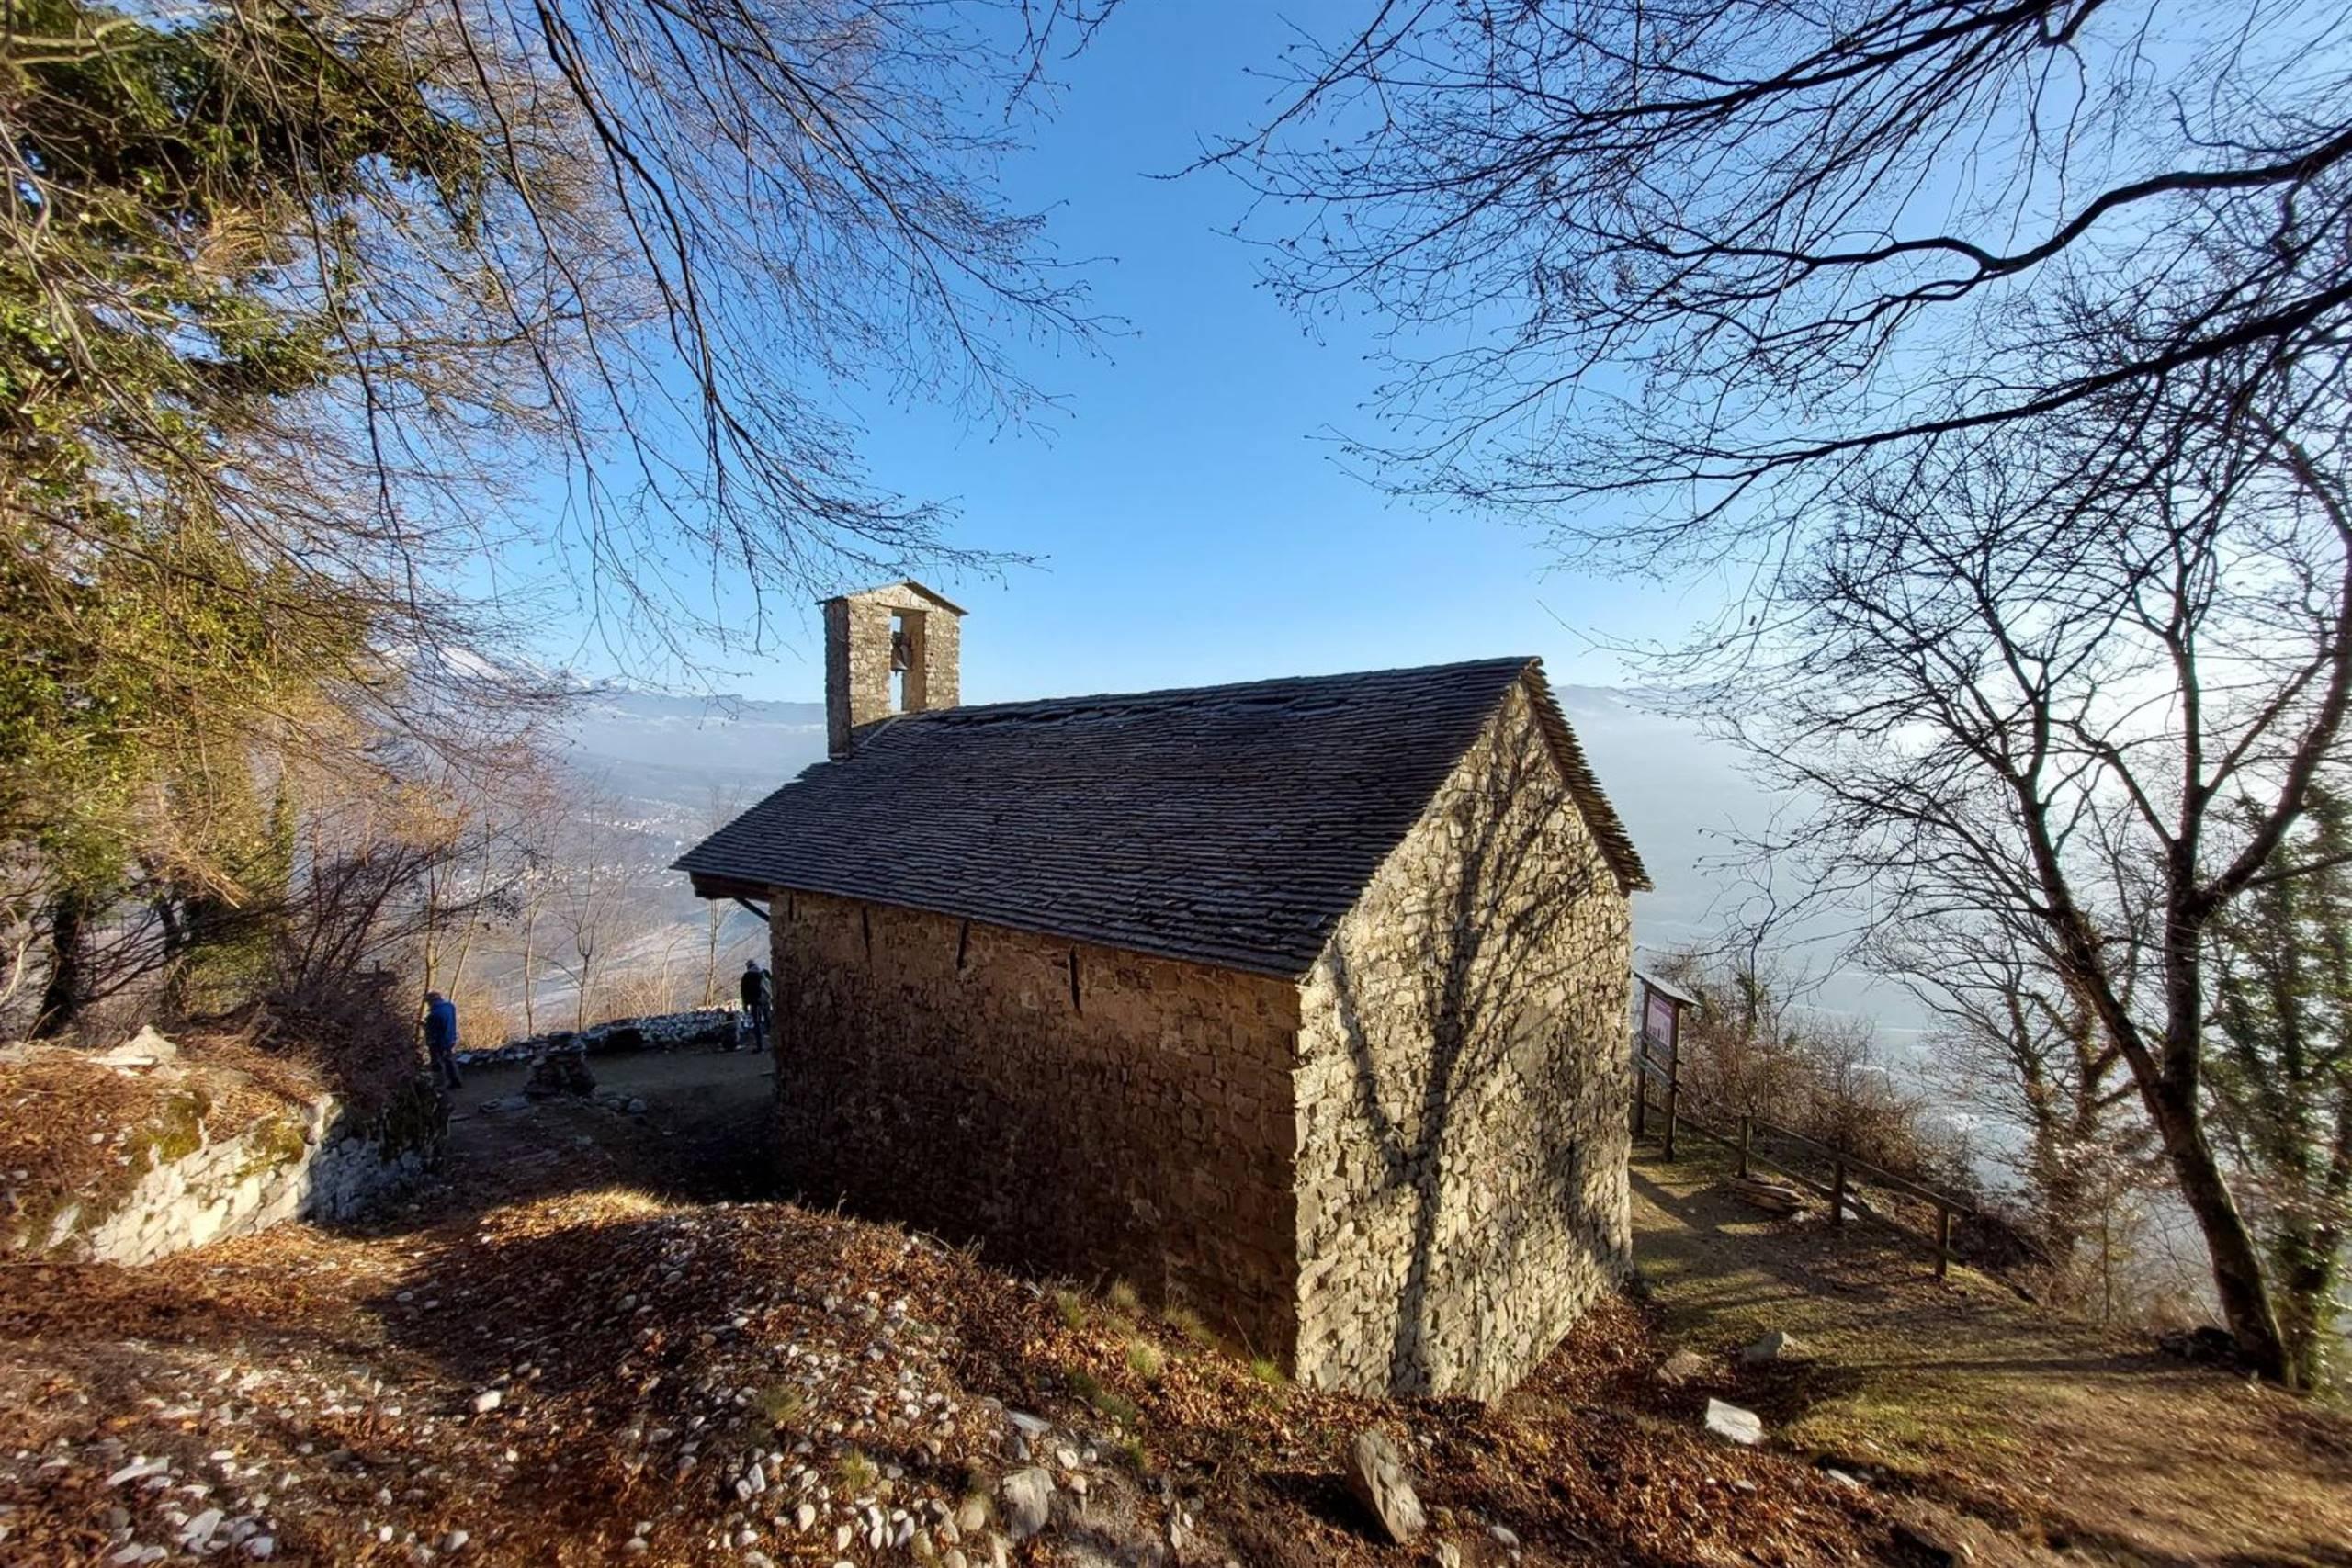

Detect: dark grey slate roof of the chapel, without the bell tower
675,659,1649,976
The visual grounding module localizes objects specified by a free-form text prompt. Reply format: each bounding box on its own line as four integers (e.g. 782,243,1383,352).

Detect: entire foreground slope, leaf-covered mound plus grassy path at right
0,1055,2352,1568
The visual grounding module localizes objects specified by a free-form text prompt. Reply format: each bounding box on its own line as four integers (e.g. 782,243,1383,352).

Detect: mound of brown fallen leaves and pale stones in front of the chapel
0,1146,1947,1568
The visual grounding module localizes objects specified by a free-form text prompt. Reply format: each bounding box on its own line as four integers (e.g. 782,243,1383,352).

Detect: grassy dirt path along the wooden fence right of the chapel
1633,1149,2352,1568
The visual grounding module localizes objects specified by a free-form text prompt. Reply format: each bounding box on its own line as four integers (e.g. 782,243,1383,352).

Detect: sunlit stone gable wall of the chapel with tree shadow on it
1296,689,1633,1399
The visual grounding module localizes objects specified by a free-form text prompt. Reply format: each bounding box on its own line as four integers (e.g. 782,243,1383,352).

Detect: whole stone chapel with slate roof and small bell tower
677,583,1649,1399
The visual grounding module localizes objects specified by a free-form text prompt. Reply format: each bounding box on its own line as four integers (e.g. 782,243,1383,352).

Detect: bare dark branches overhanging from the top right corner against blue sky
1211,0,2352,555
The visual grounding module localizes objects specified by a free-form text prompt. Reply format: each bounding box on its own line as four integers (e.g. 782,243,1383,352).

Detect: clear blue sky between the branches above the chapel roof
560,0,1693,701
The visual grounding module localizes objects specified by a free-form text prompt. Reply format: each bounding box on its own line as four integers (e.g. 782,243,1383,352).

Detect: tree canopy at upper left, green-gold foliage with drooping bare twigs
0,0,1091,1029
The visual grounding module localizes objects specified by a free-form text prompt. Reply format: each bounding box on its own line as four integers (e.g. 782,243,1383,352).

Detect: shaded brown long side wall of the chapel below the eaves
772,894,1298,1359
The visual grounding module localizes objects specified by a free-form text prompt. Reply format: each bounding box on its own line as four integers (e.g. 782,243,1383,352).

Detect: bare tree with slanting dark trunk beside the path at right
1708,338,2352,1378
